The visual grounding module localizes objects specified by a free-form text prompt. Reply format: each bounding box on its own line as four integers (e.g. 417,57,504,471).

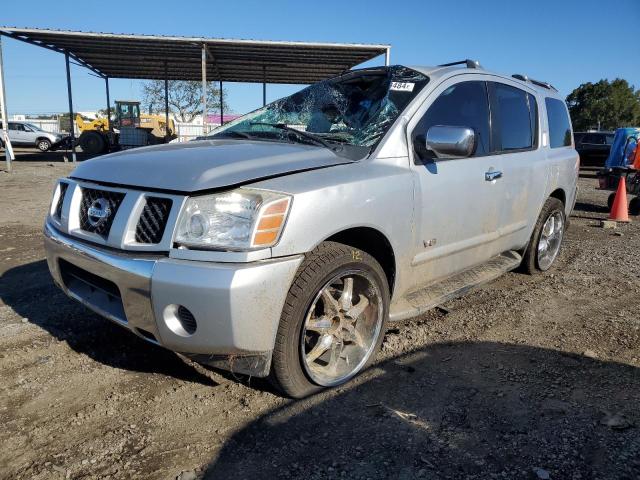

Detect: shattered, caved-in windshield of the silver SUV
210,66,429,158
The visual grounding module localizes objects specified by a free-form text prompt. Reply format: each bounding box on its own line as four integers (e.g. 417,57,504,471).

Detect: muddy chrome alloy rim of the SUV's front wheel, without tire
300,270,384,387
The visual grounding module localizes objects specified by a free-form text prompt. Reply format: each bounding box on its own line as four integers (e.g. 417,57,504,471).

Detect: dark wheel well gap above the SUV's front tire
323,227,396,296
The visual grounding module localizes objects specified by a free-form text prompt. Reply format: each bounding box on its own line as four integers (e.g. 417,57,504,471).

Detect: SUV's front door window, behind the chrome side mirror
412,81,490,158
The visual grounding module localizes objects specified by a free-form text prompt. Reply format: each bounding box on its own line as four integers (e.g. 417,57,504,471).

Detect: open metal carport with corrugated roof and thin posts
0,27,391,169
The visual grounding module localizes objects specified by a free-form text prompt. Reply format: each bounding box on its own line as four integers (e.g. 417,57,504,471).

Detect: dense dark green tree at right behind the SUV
567,78,640,130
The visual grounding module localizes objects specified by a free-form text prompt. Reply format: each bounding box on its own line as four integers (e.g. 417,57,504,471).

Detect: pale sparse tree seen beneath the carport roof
142,80,228,122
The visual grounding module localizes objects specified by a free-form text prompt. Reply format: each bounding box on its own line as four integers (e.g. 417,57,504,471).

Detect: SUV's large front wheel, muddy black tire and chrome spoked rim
270,242,389,398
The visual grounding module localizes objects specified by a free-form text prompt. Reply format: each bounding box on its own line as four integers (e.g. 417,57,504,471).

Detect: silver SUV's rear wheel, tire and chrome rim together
522,198,566,275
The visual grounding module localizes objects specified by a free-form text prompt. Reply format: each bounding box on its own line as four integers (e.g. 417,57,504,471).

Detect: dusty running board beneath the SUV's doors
389,251,522,321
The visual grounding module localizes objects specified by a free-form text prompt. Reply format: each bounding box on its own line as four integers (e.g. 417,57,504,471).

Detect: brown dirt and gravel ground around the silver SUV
0,161,640,480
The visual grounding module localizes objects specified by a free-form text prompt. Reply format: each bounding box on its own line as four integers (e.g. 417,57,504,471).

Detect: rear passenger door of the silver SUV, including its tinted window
487,81,546,251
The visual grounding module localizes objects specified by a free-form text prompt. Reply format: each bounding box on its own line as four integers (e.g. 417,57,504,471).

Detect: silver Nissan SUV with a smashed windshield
44,61,578,397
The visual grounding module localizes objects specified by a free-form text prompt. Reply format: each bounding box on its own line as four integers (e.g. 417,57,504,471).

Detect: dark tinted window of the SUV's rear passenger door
489,82,538,152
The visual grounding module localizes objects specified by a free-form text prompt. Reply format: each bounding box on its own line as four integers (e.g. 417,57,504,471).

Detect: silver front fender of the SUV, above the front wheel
254,161,414,292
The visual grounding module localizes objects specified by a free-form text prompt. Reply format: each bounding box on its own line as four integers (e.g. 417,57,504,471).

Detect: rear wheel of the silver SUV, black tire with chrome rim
522,197,567,275
